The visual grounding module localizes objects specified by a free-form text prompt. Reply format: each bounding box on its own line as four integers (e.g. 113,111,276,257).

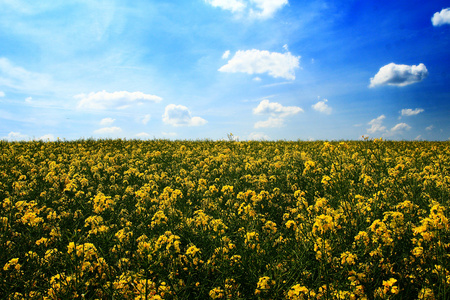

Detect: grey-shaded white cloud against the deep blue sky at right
369,63,428,87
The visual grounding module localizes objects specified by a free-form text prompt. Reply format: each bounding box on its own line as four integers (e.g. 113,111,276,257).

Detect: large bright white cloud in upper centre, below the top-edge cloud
219,49,300,80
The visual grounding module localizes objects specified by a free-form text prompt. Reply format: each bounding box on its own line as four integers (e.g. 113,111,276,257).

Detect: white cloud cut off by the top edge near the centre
205,0,288,19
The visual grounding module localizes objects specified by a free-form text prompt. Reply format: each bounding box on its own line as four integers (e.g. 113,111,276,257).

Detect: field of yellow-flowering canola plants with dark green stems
0,139,450,299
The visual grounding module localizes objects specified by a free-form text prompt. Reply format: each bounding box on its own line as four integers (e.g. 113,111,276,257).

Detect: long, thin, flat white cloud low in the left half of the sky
75,91,162,109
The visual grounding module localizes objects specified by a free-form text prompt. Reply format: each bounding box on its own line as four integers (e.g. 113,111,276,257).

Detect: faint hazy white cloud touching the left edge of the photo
0,57,51,91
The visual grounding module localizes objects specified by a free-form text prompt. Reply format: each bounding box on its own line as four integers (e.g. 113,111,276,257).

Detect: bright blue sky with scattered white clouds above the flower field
0,0,450,140
